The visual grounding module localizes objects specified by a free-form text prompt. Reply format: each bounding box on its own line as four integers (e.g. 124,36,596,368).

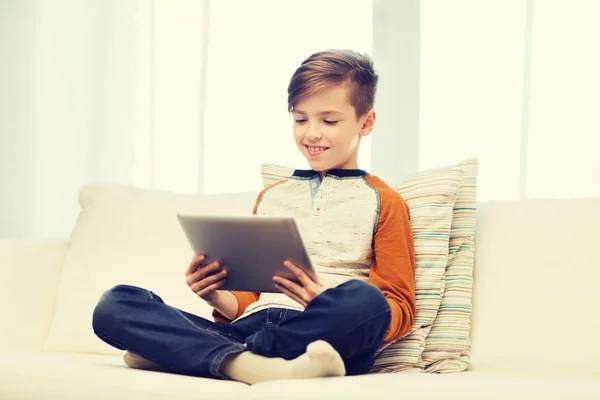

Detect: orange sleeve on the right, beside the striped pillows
367,176,416,342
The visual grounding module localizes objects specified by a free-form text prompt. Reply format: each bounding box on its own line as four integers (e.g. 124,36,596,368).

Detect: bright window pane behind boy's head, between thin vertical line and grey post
204,0,372,194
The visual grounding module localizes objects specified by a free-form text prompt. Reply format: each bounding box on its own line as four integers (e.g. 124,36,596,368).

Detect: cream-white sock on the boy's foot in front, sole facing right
222,340,346,384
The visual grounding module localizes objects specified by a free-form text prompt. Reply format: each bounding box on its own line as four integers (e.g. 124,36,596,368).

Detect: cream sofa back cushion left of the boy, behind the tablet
46,184,256,354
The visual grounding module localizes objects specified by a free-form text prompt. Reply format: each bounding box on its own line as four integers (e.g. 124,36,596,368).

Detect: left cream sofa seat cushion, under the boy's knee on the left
0,352,249,400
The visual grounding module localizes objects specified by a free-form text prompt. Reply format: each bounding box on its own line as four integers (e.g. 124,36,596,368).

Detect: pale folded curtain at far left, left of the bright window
0,0,136,238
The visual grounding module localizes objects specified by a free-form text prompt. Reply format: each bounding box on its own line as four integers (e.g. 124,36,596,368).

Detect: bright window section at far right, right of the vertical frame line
527,0,600,197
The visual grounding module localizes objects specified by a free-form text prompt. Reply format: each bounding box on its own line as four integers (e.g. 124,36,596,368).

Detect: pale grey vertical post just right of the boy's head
371,0,420,185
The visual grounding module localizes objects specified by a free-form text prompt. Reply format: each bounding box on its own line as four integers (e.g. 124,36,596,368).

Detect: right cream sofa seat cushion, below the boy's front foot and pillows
248,371,600,400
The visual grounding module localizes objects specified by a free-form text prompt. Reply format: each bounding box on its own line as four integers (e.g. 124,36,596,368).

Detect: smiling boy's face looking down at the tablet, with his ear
292,84,375,177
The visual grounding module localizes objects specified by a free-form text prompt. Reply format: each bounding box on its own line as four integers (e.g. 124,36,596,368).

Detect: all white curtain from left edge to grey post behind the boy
0,0,372,237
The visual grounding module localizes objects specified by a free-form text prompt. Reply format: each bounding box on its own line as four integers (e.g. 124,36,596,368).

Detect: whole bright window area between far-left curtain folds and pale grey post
132,0,373,194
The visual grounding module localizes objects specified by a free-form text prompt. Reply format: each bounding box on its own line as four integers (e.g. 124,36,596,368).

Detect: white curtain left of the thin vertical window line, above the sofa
0,0,207,238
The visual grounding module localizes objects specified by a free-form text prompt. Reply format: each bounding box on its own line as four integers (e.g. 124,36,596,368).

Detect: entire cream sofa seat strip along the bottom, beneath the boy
0,352,600,400
